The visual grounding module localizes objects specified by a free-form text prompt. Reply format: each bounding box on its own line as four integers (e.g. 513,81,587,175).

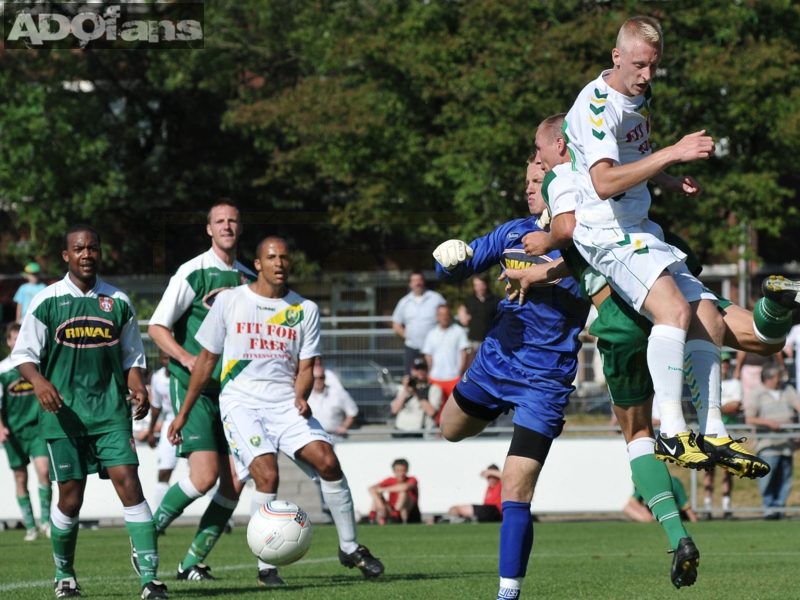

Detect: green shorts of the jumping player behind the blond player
589,294,653,406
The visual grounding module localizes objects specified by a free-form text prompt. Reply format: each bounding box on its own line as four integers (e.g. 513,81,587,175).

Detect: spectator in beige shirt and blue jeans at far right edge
745,363,800,519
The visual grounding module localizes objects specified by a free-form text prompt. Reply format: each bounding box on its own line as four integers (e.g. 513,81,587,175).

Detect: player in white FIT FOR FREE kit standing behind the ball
168,237,383,584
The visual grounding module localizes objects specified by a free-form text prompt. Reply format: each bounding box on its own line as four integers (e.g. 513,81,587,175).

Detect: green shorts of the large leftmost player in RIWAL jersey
47,430,139,481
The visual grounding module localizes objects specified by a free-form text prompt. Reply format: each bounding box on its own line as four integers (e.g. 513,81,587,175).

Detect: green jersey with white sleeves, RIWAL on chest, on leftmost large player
11,274,145,439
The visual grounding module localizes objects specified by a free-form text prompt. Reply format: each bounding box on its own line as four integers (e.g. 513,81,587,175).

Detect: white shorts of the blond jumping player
573,219,717,317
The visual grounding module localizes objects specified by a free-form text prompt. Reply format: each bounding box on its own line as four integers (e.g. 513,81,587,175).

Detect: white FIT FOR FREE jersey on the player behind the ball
196,285,320,412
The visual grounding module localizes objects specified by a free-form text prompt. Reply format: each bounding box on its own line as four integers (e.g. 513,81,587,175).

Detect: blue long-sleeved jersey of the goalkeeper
436,217,589,377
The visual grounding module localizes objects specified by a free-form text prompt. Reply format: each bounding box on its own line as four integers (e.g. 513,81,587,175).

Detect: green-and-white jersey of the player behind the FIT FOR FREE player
150,249,256,388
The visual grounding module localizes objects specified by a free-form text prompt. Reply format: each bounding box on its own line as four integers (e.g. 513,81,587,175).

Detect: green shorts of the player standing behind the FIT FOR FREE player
169,375,230,458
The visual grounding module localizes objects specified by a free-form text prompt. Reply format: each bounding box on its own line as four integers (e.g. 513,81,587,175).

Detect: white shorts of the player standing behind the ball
222,402,331,482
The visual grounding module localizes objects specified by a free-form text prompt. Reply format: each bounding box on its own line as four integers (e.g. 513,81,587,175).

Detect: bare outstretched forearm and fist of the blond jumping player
589,130,714,200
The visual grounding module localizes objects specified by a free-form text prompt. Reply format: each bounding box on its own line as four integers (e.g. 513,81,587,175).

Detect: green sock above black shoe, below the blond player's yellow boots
631,454,691,550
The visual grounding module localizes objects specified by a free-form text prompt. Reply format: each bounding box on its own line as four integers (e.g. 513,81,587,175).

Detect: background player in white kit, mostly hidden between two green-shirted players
147,350,178,507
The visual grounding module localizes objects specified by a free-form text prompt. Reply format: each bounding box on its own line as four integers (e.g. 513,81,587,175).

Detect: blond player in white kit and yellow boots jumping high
564,17,764,475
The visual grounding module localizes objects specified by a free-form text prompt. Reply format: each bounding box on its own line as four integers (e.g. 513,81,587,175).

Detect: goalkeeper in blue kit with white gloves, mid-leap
434,162,589,598
